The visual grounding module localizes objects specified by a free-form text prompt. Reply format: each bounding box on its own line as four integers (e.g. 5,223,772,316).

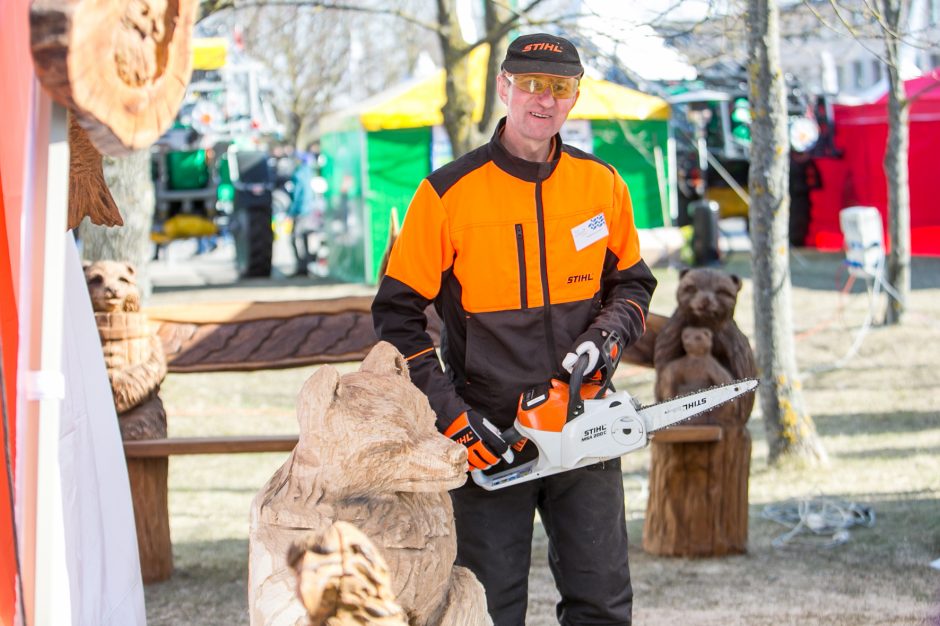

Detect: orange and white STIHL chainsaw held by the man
471,333,757,491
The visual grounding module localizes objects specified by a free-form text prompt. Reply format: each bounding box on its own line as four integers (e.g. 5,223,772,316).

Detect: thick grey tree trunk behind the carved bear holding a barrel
78,150,154,297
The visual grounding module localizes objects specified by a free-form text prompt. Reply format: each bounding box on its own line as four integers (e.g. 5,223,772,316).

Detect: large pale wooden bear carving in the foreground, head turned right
248,342,489,626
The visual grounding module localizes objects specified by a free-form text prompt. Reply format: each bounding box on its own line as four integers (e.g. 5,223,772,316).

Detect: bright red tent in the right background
806,69,940,255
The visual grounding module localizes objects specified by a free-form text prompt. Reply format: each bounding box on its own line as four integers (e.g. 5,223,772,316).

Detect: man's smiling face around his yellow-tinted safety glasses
497,74,580,141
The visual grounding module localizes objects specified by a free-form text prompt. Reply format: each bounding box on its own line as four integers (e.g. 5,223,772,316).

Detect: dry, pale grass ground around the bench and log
147,253,940,626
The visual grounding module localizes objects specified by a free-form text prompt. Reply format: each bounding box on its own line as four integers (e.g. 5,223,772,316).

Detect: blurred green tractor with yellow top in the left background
151,38,281,277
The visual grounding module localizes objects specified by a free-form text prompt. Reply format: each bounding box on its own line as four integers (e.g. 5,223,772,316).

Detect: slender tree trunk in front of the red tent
884,0,911,324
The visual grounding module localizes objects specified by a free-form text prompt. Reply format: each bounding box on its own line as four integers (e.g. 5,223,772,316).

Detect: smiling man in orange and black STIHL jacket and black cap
372,34,656,626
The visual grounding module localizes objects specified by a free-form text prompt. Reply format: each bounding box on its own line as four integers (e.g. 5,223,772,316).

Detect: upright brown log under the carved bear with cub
643,427,751,557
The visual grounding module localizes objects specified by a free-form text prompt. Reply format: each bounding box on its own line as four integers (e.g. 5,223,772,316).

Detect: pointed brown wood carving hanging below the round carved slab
68,115,124,230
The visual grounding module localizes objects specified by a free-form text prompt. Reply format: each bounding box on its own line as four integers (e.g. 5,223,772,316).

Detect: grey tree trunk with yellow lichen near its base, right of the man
747,0,827,464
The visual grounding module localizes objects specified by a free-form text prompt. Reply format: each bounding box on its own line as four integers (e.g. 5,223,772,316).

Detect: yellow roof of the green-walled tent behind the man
359,46,669,131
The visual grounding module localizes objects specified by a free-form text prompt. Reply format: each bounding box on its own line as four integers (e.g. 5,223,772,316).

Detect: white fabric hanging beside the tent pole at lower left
59,233,147,626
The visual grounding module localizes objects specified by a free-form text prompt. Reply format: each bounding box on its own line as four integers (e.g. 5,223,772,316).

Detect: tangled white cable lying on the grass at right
761,497,875,549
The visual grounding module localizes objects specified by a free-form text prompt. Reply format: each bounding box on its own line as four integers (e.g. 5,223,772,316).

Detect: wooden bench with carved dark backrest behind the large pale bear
124,296,414,583
